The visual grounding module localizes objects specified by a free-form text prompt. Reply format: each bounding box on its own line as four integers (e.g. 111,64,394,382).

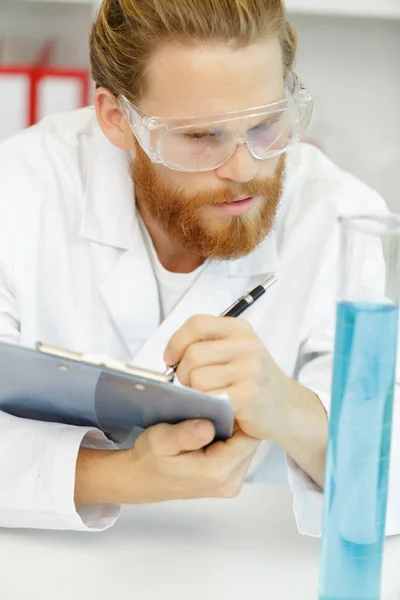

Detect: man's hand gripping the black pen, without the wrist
164,316,291,439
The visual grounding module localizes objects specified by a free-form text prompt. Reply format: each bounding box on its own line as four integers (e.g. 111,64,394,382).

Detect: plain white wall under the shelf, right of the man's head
292,11,400,212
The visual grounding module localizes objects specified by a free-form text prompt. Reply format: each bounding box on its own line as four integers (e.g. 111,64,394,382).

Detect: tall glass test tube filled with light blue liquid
319,215,400,600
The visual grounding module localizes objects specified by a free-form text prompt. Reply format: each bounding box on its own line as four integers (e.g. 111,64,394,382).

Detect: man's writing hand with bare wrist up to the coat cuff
164,315,328,487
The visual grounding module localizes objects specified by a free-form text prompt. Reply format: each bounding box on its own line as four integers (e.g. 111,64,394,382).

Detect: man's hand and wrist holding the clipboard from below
75,421,260,507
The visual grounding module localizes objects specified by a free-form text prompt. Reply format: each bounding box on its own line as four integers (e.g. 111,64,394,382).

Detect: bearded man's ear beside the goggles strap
94,87,133,150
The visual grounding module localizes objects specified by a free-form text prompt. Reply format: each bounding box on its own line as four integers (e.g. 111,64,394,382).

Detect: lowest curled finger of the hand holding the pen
177,358,261,392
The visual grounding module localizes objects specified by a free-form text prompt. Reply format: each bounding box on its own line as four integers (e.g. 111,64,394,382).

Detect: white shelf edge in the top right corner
286,0,400,19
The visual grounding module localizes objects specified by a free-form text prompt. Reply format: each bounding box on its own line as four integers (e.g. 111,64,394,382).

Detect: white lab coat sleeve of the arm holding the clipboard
0,270,119,531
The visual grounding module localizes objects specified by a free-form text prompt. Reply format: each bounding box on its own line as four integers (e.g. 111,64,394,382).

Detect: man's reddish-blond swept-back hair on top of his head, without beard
90,0,297,102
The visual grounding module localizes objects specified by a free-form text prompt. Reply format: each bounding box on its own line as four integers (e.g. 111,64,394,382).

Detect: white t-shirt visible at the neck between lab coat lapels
138,214,207,321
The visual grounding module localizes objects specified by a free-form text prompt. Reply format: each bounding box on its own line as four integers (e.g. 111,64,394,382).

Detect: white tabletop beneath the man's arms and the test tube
0,485,400,600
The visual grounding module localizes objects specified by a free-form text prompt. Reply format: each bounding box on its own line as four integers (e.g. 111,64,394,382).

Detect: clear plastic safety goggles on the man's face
119,73,313,172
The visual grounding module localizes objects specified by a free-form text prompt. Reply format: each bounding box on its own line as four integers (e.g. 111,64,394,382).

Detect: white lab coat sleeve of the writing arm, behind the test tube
286,218,400,537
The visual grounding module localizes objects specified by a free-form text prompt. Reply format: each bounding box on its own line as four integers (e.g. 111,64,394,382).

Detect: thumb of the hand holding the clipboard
145,420,215,456
